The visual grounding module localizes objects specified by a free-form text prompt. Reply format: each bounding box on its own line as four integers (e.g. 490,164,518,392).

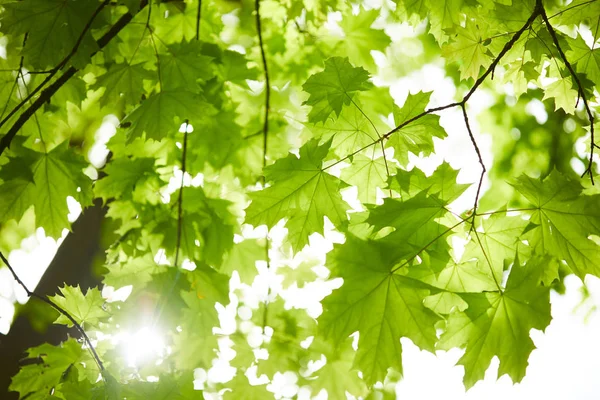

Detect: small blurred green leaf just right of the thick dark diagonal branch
91,63,154,106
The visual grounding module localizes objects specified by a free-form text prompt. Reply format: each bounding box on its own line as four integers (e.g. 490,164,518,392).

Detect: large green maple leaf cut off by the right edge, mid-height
513,171,600,279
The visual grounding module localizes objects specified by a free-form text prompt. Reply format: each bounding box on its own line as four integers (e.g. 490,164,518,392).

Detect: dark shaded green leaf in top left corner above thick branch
1,0,101,70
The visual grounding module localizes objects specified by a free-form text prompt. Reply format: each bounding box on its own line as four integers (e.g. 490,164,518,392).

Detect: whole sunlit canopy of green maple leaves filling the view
0,0,600,399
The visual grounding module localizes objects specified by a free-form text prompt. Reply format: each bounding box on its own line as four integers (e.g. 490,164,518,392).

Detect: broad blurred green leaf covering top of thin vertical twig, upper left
122,90,214,141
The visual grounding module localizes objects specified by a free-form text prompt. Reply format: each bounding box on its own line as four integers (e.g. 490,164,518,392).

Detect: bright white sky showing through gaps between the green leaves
0,2,600,400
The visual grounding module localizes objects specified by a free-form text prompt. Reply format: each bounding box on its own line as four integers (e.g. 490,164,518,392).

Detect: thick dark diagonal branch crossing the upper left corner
0,0,148,159
